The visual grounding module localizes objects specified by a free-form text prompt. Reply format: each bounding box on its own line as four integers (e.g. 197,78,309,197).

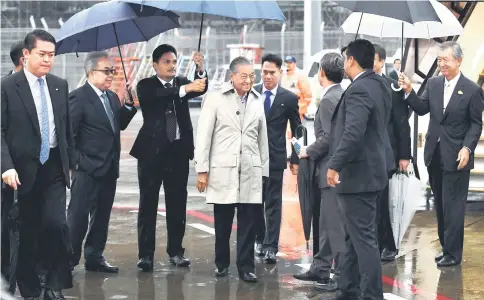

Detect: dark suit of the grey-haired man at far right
407,74,484,263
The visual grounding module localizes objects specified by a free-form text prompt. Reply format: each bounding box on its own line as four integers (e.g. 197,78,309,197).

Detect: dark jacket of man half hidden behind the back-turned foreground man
382,75,412,165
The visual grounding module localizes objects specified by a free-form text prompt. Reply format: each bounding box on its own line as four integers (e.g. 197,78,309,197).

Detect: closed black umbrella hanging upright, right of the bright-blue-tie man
294,125,316,249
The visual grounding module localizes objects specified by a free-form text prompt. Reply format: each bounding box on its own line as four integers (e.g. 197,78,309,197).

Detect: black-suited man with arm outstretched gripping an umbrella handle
130,44,208,271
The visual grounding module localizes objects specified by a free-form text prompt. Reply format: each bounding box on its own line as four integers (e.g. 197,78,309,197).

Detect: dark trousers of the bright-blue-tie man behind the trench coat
255,170,284,253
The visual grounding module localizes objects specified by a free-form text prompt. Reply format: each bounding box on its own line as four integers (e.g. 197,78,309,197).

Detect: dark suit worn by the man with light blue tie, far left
1,72,73,297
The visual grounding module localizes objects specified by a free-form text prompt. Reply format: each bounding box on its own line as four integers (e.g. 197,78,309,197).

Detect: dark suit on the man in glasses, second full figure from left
67,82,136,265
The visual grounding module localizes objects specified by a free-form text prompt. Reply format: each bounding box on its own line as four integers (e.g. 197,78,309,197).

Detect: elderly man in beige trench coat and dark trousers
195,57,269,282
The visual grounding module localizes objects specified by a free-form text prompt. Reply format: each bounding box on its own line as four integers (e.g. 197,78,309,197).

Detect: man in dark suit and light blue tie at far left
1,29,73,300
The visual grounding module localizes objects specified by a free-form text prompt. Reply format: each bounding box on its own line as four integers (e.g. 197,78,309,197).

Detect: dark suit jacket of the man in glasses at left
69,82,136,177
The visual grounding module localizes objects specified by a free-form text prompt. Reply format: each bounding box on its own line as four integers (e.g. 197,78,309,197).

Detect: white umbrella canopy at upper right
341,0,464,39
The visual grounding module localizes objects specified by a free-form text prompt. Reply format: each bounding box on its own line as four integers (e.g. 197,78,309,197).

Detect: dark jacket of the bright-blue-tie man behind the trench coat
254,84,301,170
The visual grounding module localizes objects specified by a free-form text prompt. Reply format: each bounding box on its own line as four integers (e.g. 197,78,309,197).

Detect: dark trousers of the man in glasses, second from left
67,170,117,265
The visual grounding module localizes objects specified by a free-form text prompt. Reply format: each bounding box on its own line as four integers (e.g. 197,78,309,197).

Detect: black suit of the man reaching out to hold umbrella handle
130,74,208,259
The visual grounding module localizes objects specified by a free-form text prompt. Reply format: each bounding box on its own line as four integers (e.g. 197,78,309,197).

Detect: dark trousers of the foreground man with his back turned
337,192,383,300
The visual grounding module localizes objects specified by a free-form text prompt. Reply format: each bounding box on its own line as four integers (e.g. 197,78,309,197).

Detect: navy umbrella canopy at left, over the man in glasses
56,1,180,55
